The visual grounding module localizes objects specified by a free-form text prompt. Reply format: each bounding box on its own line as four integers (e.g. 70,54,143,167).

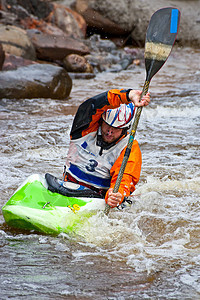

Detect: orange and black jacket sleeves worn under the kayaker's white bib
70,89,142,201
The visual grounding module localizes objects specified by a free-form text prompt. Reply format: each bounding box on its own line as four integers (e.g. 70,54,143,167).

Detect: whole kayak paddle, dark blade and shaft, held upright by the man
104,7,180,215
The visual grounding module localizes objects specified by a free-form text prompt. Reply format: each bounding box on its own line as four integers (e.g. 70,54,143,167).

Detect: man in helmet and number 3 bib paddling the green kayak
64,89,150,208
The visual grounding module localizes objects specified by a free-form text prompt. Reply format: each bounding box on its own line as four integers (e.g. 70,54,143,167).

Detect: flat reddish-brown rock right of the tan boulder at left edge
27,30,90,61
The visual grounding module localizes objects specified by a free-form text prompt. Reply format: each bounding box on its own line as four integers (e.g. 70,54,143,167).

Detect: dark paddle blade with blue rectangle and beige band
144,7,180,81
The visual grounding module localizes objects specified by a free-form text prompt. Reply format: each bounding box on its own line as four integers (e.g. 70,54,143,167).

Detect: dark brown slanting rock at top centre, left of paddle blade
75,0,127,35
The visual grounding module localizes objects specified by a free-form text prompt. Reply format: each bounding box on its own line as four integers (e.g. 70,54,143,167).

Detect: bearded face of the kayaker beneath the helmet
101,121,123,144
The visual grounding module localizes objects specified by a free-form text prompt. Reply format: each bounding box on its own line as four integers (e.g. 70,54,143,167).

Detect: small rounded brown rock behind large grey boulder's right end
63,54,93,73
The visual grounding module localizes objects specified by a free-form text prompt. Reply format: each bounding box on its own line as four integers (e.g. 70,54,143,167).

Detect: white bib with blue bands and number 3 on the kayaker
66,131,129,189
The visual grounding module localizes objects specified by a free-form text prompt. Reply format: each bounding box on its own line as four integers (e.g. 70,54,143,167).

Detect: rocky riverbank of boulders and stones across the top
0,0,200,99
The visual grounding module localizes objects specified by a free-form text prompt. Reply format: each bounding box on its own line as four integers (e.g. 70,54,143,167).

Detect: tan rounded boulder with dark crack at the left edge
0,24,36,60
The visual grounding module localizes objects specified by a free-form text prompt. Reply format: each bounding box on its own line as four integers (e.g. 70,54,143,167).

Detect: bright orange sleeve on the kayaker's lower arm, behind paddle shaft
105,140,142,204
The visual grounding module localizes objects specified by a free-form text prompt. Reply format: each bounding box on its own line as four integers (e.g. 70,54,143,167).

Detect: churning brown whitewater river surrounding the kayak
0,48,200,300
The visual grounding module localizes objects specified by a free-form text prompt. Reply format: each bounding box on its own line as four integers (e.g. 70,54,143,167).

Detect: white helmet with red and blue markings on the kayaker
102,102,134,128
